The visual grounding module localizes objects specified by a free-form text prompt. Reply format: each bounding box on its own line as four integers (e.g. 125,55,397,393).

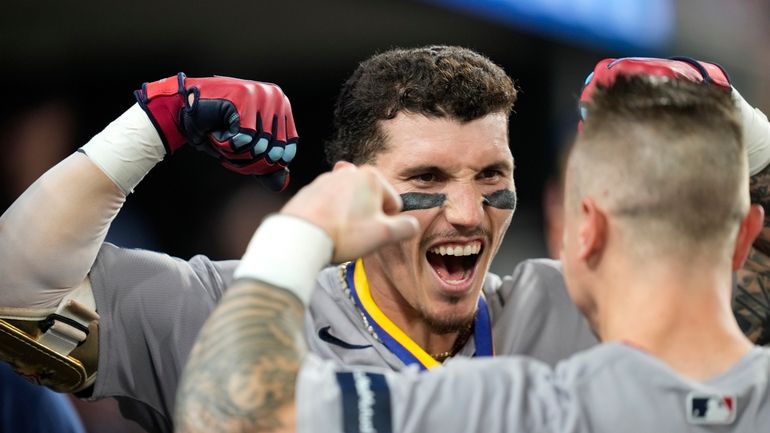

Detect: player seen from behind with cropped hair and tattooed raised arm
177,64,770,433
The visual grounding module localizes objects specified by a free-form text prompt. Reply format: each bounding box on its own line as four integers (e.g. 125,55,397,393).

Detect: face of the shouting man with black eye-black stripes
366,113,514,333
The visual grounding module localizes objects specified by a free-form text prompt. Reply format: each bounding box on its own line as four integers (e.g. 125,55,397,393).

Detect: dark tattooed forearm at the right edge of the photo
733,166,770,345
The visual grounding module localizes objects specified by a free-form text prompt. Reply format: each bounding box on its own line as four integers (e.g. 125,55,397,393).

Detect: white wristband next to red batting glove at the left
80,104,166,195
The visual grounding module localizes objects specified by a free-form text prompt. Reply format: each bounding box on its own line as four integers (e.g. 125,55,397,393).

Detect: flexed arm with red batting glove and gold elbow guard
0,74,297,392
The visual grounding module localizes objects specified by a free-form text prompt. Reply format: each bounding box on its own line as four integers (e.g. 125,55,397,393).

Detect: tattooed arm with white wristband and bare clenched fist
175,164,418,433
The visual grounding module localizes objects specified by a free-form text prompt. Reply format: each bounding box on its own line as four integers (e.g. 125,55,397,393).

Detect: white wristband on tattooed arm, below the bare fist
234,214,334,305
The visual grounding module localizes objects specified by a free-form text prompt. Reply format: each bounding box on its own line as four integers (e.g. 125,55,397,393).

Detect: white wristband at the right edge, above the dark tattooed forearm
733,88,770,176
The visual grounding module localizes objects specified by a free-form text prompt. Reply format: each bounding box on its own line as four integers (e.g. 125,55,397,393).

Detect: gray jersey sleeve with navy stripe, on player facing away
297,355,578,433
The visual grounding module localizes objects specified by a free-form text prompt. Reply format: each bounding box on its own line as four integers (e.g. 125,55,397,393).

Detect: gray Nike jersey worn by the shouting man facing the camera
85,244,595,432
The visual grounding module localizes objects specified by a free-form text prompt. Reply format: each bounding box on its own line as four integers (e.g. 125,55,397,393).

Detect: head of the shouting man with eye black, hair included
327,46,516,333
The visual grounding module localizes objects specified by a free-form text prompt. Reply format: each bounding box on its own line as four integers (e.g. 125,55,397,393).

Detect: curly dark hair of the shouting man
326,46,516,164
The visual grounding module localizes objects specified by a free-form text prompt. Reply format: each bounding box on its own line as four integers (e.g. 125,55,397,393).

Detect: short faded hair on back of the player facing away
567,76,749,257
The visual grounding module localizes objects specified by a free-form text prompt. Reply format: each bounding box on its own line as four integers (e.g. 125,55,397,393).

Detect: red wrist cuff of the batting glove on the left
134,72,187,155
